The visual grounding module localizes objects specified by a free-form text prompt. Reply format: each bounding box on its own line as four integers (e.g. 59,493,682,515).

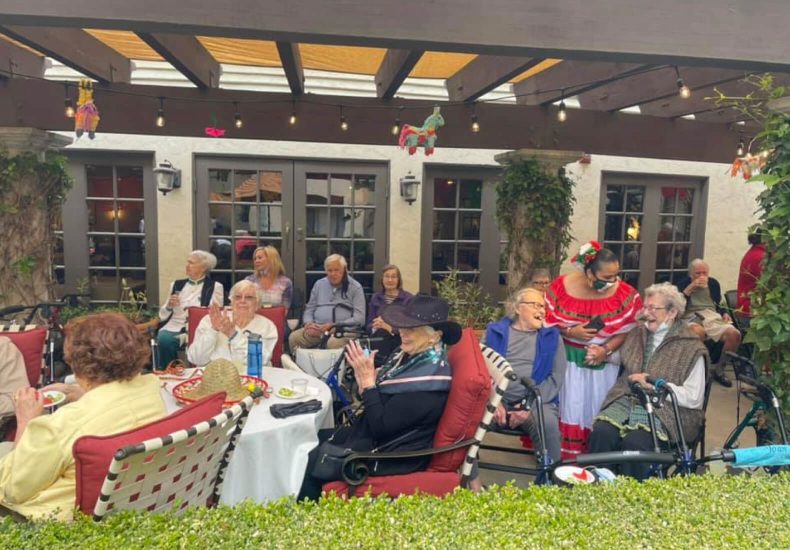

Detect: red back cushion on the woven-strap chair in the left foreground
71,392,225,515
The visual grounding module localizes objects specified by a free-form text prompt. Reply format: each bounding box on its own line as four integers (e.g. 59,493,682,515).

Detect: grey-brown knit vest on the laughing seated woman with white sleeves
601,326,710,441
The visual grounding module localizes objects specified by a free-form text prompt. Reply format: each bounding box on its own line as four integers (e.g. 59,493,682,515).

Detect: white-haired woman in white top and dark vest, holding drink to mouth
157,250,224,369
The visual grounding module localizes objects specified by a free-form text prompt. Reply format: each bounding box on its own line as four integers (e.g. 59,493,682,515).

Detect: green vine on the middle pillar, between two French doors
496,159,575,293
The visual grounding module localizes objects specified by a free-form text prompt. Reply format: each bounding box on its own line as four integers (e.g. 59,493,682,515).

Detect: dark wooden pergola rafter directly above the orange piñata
0,24,132,84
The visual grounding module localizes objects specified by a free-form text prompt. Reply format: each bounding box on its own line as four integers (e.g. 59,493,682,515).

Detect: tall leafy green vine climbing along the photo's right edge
715,75,790,410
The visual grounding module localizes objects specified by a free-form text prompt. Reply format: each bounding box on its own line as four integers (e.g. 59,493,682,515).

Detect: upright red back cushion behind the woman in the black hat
428,329,491,472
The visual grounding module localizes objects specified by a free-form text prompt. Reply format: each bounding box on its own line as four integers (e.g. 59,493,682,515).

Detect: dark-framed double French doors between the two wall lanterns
195,157,389,300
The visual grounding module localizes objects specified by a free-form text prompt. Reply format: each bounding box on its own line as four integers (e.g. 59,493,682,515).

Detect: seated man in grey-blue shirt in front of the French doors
288,254,365,352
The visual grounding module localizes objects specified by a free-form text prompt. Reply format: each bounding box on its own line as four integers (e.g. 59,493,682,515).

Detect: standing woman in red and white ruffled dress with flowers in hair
546,241,642,458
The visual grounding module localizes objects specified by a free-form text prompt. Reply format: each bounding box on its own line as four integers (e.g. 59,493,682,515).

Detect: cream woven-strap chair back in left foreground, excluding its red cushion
75,394,253,521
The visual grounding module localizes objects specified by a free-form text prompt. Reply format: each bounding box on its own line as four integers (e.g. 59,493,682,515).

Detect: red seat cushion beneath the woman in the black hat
322,472,461,497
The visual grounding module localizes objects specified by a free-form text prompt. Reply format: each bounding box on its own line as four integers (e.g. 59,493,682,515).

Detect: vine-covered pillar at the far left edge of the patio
0,150,72,305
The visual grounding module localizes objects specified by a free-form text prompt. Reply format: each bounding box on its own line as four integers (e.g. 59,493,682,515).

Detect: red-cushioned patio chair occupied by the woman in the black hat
323,329,513,497
